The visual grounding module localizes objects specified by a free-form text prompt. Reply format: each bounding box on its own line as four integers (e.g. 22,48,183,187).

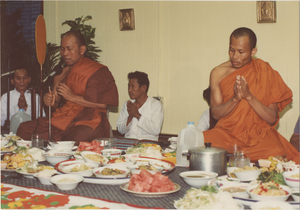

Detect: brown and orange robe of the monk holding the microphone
17,58,118,144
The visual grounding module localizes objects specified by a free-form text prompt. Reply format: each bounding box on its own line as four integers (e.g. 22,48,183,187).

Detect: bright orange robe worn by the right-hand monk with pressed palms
203,59,299,164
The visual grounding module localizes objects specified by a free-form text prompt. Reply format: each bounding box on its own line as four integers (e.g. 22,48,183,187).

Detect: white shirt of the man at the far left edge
1,89,46,126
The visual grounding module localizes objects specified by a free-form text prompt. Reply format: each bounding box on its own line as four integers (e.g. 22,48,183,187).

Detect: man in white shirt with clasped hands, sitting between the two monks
117,71,164,141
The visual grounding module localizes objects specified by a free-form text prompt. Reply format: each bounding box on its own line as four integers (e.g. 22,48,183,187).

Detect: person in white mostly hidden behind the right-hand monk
197,87,218,132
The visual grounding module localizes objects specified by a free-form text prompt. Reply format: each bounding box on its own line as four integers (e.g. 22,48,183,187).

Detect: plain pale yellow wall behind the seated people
44,1,299,139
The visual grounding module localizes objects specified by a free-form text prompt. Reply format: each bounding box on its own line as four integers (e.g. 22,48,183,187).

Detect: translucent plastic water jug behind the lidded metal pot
176,122,204,166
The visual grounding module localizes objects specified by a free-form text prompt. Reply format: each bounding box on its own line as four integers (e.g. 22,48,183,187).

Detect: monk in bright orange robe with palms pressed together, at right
203,28,299,164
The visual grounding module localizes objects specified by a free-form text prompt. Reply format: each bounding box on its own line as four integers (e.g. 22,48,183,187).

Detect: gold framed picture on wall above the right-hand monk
256,1,276,23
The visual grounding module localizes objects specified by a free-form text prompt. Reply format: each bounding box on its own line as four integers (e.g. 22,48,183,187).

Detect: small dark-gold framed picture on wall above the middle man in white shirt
119,9,135,31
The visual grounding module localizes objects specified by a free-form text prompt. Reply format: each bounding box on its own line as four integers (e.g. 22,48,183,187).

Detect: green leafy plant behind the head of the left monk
62,15,102,61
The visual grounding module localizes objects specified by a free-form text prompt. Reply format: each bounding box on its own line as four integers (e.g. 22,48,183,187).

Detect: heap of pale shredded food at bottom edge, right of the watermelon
174,188,240,210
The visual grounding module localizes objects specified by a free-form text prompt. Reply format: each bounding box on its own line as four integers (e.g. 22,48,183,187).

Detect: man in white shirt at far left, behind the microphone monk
1,68,39,126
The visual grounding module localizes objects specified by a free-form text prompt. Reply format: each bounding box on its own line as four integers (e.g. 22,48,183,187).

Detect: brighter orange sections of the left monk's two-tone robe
51,58,106,131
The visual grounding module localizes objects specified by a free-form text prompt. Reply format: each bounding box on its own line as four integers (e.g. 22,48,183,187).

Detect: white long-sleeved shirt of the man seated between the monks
117,97,164,141
